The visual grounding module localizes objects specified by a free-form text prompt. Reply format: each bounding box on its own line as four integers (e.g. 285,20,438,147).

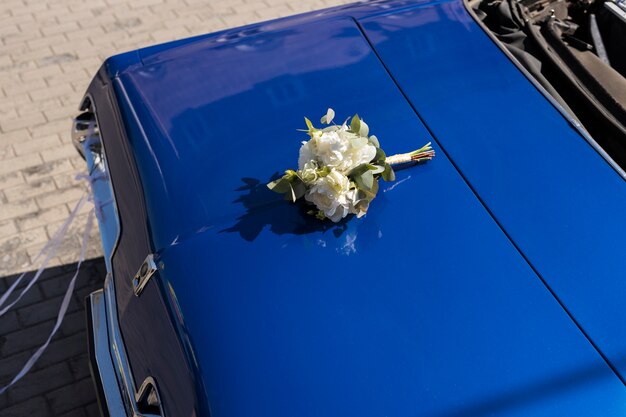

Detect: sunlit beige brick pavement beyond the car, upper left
0,0,351,277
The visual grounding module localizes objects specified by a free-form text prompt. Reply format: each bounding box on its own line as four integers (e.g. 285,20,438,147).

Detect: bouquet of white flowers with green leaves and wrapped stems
267,109,435,223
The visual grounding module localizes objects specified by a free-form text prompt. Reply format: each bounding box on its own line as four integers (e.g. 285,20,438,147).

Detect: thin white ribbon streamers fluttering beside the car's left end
0,208,94,394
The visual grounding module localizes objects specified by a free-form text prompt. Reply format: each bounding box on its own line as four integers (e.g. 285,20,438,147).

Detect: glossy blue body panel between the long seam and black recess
362,2,626,379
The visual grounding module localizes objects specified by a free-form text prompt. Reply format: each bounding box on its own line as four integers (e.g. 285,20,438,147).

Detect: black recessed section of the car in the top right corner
468,0,626,168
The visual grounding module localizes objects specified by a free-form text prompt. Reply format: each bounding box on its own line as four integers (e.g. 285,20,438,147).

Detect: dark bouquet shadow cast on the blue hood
220,173,354,242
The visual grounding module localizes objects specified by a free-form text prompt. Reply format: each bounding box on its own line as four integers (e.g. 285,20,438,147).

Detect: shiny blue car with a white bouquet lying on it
78,0,626,417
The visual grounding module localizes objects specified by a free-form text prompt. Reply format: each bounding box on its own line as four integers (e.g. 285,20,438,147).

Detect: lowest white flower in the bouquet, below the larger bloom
304,169,354,223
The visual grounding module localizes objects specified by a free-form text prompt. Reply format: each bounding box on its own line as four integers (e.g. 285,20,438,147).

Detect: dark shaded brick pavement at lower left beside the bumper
0,258,105,417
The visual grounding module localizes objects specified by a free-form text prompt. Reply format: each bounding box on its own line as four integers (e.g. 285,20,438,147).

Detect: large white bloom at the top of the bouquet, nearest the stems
298,125,376,173
